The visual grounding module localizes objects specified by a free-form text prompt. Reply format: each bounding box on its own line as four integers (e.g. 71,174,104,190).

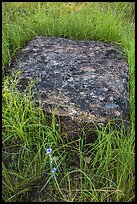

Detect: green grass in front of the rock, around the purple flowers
2,75,134,202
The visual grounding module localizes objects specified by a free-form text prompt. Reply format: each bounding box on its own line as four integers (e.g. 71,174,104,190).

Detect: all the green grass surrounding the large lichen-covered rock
2,2,135,202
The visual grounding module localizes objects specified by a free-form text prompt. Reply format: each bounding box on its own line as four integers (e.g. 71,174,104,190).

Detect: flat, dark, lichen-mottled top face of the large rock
8,36,129,139
